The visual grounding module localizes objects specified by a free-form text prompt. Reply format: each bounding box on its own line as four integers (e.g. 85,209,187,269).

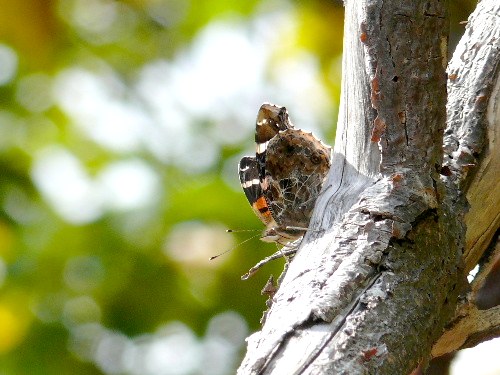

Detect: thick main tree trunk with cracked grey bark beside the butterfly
238,0,498,374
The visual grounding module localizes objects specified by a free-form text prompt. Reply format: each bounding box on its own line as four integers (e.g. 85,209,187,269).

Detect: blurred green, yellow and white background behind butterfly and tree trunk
0,0,500,375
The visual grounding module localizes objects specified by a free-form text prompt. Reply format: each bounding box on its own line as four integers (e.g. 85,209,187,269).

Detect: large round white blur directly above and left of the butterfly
169,21,268,116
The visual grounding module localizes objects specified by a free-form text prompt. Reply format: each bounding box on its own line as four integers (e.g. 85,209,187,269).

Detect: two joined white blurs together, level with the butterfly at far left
31,147,159,224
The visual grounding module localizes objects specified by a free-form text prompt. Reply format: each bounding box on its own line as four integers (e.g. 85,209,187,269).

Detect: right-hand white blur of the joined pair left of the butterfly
98,159,161,210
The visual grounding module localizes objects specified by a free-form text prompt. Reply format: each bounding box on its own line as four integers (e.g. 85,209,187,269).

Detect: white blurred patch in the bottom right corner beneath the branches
450,338,500,375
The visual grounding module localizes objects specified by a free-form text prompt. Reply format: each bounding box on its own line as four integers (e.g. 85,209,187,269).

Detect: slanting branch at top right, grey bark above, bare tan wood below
444,0,500,270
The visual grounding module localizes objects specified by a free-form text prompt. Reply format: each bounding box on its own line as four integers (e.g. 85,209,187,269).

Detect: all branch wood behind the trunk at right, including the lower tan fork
432,0,500,356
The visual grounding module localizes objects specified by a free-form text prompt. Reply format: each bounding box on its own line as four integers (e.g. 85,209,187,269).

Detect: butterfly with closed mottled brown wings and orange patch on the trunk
239,103,331,245
